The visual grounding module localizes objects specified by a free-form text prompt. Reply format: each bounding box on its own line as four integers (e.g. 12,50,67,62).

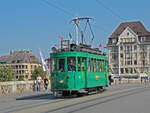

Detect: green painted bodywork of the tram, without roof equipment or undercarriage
51,52,109,91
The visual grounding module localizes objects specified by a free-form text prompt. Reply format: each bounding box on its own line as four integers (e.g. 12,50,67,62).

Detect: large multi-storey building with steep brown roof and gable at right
107,21,150,77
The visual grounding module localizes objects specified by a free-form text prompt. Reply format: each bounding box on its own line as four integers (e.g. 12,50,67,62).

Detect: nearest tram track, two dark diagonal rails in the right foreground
44,87,150,113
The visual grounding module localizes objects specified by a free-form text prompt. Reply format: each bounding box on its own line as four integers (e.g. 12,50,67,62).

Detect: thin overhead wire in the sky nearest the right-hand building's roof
96,0,126,21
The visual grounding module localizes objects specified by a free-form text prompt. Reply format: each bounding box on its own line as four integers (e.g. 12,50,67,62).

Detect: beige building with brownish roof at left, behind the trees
0,51,41,80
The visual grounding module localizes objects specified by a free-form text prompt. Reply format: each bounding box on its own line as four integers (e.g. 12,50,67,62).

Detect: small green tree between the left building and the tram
31,66,46,80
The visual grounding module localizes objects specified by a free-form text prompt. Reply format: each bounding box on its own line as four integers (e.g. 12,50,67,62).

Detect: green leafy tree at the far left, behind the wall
0,66,15,82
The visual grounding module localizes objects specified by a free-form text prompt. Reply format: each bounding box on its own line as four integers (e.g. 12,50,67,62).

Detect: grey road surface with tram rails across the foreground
0,84,150,113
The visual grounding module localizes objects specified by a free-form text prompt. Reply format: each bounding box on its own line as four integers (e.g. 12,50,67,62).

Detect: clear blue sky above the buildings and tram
0,0,150,58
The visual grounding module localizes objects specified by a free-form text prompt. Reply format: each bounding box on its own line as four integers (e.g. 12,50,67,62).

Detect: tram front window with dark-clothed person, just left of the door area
67,57,76,72
